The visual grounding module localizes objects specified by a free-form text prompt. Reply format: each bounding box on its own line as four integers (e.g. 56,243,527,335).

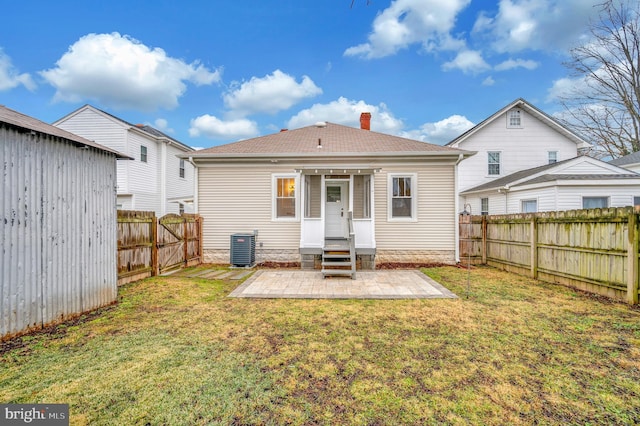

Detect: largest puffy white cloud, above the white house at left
40,33,220,111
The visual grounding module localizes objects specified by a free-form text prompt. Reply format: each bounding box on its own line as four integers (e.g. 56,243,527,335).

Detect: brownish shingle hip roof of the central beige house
192,123,472,157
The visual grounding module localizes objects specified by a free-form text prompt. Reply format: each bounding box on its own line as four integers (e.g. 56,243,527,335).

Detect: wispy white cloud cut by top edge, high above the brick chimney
344,0,470,59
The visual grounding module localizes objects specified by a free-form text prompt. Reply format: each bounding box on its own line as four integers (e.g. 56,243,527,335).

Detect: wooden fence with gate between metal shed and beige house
118,210,202,285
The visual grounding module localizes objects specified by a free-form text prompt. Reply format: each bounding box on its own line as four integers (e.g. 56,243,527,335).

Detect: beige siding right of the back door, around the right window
374,164,455,250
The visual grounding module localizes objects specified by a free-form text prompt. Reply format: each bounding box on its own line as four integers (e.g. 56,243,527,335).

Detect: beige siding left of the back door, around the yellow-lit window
198,165,302,250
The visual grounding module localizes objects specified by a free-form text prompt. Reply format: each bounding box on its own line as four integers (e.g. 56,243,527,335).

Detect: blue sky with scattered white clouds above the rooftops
0,0,601,148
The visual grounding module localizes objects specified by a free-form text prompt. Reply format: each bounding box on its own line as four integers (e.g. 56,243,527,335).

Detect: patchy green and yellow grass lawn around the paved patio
0,267,640,425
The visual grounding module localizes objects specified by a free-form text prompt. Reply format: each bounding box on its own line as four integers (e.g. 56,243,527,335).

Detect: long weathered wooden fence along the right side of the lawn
460,207,640,304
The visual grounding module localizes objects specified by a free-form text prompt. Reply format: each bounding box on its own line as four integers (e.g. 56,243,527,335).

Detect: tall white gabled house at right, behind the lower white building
447,99,590,214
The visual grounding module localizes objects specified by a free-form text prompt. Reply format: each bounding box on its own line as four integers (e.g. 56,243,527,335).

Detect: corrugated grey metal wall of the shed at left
0,123,117,337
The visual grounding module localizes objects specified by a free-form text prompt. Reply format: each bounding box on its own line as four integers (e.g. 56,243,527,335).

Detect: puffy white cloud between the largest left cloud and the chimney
224,70,322,117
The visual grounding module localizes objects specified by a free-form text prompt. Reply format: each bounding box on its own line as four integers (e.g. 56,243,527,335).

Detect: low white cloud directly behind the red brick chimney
287,97,403,134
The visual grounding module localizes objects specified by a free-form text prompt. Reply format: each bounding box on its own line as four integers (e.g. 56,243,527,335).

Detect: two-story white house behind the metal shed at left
53,105,194,216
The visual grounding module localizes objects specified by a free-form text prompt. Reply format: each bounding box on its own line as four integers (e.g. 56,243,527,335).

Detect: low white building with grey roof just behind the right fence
460,156,640,214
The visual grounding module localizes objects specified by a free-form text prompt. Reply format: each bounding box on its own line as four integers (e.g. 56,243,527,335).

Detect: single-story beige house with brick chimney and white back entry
188,113,472,268
